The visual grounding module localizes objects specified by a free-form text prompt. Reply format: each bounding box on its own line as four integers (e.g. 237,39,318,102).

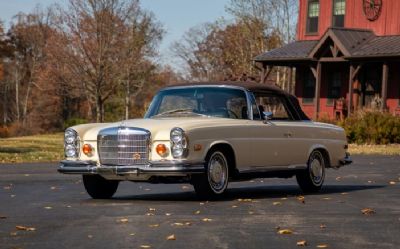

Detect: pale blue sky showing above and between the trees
0,0,229,64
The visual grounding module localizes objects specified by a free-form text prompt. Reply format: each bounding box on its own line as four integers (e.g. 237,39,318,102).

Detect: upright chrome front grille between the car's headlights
97,127,150,166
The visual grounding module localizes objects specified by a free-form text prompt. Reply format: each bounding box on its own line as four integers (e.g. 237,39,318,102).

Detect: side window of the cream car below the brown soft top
256,94,293,120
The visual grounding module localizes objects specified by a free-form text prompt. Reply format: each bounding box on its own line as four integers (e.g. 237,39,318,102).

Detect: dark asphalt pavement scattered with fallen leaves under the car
0,156,400,249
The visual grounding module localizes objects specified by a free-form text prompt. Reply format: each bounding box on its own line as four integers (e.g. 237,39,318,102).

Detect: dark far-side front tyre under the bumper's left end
82,175,119,199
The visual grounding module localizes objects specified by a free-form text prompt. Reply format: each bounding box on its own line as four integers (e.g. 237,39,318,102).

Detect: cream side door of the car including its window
250,92,298,169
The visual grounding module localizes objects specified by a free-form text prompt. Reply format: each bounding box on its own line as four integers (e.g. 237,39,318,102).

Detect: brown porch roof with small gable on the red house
254,28,400,62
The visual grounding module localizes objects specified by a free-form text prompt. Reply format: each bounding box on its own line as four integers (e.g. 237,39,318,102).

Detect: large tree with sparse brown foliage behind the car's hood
51,0,163,122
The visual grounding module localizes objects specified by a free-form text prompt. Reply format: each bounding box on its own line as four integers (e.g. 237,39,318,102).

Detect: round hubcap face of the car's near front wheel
208,152,228,193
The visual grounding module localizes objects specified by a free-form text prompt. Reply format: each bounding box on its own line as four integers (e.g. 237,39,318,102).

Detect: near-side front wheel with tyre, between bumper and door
192,151,229,199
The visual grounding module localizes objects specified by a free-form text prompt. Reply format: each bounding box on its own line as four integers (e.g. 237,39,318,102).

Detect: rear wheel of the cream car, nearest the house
296,150,325,193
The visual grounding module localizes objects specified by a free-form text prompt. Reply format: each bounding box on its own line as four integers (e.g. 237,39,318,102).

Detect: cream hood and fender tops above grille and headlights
71,117,248,141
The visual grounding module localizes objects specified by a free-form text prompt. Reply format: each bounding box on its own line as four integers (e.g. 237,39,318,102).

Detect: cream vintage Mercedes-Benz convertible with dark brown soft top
58,82,352,199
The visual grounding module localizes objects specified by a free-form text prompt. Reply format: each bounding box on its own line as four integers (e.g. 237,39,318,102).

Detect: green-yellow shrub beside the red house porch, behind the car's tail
339,111,400,144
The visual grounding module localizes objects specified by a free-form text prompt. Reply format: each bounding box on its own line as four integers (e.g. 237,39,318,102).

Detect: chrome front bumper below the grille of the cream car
58,161,204,176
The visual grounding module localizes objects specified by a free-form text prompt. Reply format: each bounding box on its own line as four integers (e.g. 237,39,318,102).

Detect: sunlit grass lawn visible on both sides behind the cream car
0,133,400,163
